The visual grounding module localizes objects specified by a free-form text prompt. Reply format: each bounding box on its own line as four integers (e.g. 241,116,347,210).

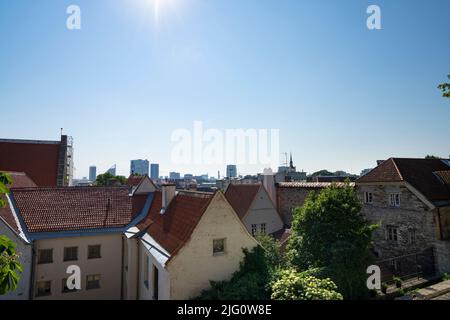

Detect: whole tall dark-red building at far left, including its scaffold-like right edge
0,135,73,187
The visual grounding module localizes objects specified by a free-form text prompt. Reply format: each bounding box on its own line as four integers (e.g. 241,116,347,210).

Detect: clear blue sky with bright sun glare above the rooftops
0,0,450,177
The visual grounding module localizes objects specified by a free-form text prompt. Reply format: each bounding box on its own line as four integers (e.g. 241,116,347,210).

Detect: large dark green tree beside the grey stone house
287,183,376,299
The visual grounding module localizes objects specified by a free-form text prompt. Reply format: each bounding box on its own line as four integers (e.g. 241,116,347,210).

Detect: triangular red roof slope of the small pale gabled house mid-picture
225,184,261,219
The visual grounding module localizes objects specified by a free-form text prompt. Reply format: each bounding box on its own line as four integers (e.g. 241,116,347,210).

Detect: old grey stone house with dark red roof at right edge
356,158,450,275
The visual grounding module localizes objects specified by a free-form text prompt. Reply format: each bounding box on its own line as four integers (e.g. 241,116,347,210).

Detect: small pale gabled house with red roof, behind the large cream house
225,184,284,236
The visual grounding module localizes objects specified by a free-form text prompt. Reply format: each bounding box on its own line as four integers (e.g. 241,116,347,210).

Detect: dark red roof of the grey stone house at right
357,158,450,202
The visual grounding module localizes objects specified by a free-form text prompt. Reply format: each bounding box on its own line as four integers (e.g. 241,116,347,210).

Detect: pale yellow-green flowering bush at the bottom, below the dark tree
271,269,343,300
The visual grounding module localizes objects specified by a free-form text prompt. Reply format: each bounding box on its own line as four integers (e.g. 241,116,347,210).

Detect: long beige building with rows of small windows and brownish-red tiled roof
4,187,153,299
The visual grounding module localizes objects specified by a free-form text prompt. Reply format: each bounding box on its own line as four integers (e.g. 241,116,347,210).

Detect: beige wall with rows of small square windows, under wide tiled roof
33,233,123,300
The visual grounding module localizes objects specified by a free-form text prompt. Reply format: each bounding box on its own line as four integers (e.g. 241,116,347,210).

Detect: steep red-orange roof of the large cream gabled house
137,191,214,256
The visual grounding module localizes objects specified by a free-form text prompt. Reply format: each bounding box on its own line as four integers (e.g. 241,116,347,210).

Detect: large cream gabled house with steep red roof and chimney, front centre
125,185,257,300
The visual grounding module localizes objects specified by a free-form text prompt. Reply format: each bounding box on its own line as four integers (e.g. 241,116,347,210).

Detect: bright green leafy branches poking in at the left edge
0,172,22,295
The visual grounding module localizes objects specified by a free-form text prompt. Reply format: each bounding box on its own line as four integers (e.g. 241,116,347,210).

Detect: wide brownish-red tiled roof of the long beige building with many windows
11,187,133,233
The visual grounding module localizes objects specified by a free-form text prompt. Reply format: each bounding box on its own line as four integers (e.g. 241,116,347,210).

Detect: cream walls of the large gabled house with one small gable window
127,192,258,300
